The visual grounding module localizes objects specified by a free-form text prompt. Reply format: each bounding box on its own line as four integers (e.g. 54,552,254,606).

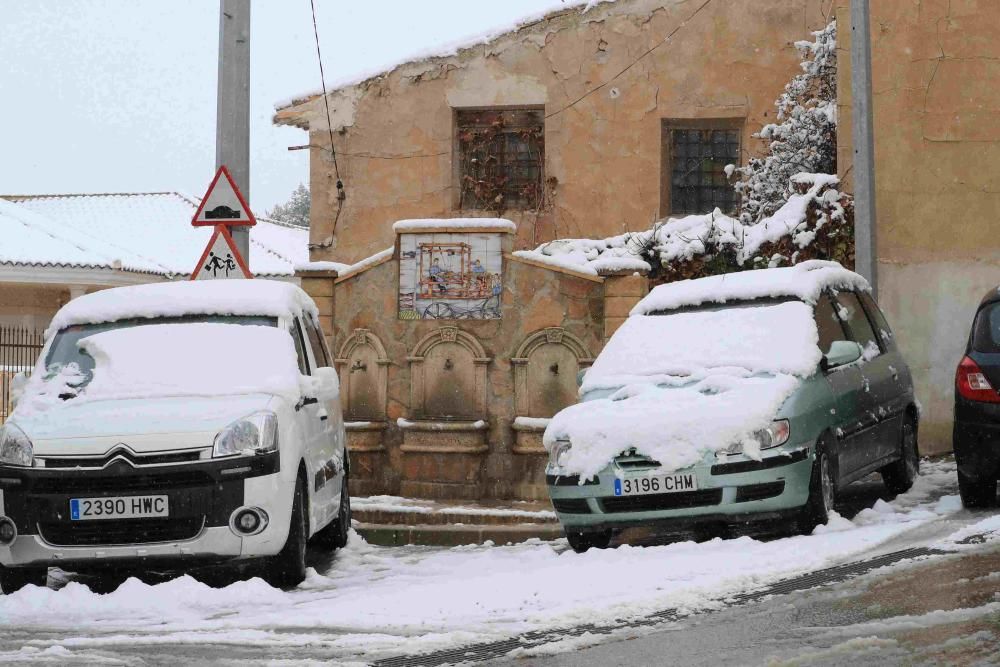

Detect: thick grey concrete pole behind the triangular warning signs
215,0,250,264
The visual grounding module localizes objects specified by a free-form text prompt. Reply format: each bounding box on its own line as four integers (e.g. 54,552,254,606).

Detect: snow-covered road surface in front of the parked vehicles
0,462,981,664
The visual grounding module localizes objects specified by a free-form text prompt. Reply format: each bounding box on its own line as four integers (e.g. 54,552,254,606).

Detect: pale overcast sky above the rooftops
0,0,578,212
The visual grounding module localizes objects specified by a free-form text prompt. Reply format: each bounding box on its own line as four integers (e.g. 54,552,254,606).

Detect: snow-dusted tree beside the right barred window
734,20,837,225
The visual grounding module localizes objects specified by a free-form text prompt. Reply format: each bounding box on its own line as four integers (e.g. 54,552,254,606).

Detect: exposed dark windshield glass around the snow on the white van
45,315,278,390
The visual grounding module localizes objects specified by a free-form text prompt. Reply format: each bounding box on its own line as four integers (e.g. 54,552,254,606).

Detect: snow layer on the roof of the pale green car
630,260,870,315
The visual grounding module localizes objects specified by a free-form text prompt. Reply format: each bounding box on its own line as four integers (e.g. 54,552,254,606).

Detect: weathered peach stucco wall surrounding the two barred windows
276,0,832,262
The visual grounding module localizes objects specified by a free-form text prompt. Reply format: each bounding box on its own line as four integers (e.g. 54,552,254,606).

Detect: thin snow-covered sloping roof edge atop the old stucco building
272,0,618,117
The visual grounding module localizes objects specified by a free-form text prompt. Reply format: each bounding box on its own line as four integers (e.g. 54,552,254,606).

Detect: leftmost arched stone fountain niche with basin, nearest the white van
335,329,390,495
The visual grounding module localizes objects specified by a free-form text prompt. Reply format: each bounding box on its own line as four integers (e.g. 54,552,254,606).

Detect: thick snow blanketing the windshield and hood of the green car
544,301,821,478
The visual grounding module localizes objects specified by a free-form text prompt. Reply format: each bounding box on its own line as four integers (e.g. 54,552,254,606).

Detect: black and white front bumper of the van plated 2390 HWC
0,453,294,569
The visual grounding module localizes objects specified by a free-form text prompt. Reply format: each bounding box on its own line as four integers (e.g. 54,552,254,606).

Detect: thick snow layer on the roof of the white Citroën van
45,279,317,336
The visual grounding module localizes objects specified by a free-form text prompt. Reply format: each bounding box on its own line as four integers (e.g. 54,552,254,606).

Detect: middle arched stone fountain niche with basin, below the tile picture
398,327,490,498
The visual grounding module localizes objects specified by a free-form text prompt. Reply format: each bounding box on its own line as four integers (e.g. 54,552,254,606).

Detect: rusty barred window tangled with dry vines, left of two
455,109,545,211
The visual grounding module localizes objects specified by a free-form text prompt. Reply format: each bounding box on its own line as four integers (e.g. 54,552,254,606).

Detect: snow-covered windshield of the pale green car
584,299,821,391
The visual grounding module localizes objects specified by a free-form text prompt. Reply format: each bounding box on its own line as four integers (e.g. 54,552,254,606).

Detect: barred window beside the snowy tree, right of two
660,118,743,215
